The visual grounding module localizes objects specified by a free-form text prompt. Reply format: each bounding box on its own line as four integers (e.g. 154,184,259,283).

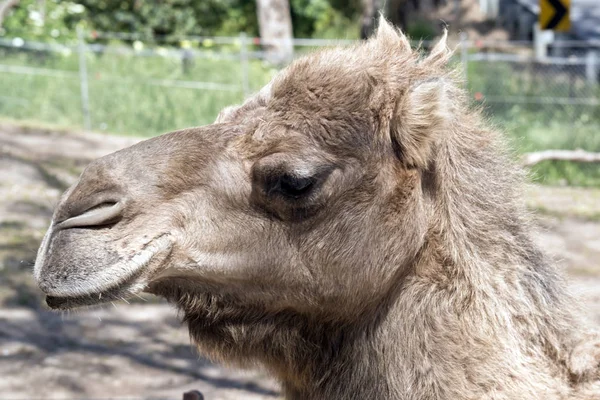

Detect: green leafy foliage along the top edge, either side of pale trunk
0,0,360,41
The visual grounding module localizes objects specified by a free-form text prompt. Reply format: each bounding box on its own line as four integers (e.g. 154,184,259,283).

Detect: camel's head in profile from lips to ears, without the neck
35,22,455,320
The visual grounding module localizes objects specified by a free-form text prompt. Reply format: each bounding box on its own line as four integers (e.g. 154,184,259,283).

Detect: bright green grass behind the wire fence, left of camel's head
0,46,274,136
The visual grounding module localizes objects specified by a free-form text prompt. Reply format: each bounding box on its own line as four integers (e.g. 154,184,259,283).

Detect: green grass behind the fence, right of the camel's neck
468,62,600,187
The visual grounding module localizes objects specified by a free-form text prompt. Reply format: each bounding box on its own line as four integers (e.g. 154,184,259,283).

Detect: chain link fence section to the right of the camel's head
465,42,600,108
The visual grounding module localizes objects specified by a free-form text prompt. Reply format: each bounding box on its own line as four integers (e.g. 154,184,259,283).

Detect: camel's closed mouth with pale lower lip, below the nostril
41,235,173,310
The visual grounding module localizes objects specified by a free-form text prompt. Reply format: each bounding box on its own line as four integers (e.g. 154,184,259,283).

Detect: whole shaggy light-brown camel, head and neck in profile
34,20,600,400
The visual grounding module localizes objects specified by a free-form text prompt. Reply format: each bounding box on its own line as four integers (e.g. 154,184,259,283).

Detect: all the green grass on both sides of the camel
0,49,600,186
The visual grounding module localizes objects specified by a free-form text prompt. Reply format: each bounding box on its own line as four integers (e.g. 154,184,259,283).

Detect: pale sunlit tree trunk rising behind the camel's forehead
256,0,294,64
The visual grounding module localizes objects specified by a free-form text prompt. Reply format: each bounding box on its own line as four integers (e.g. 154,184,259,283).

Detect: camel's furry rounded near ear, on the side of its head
391,78,451,168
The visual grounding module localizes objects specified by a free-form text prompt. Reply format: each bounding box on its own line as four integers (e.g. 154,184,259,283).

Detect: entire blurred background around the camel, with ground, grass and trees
0,0,600,400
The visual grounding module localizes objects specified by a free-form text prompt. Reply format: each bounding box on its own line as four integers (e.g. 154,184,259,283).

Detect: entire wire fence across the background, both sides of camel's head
0,32,600,151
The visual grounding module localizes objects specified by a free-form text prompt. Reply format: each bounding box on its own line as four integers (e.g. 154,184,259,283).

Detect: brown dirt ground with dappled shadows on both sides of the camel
0,123,600,400
